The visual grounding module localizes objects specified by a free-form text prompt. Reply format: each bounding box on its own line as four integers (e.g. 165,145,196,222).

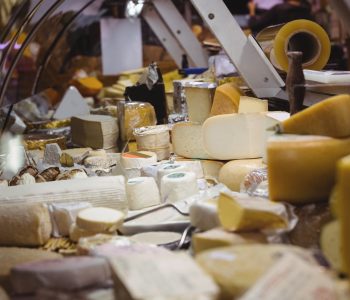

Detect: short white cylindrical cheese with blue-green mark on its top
161,172,198,203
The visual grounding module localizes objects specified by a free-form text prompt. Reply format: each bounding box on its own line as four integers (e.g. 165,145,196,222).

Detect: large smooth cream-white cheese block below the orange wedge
202,113,278,160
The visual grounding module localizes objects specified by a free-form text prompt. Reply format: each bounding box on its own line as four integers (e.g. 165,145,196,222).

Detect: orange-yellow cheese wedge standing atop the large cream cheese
210,82,241,116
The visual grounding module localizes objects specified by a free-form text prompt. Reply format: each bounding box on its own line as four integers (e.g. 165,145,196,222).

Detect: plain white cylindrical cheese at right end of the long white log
126,177,160,210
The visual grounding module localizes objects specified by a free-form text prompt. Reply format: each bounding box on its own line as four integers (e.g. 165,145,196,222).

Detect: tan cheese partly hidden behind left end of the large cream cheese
171,122,212,159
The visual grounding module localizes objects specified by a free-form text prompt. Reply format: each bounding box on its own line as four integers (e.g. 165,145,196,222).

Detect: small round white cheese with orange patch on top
120,151,157,169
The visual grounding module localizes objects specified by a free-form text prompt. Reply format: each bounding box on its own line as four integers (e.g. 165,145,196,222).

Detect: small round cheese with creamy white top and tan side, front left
76,207,124,233
